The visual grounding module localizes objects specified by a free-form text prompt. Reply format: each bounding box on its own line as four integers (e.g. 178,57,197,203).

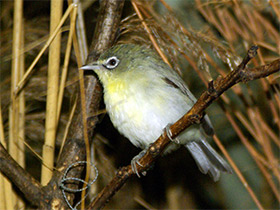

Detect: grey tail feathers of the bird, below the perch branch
185,139,232,182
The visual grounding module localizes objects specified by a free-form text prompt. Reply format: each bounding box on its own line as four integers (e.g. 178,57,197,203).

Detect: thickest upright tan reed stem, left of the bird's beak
41,0,63,185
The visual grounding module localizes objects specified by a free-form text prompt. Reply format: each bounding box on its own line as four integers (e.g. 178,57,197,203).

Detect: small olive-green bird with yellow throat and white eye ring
81,44,232,181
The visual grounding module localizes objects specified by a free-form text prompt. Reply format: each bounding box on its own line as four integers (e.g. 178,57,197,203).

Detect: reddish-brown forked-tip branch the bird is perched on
89,46,280,209
